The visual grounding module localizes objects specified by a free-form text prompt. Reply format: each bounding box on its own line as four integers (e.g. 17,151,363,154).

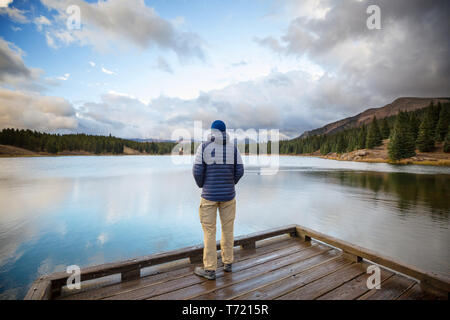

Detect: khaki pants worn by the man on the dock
199,198,236,270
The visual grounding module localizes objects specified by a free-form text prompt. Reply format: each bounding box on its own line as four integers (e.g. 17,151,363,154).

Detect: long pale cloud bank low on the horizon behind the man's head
70,71,373,139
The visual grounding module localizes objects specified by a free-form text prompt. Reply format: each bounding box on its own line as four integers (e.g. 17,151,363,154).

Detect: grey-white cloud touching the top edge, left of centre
42,0,204,59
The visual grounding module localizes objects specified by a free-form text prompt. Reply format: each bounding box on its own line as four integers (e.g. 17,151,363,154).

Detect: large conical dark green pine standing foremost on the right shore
388,112,416,160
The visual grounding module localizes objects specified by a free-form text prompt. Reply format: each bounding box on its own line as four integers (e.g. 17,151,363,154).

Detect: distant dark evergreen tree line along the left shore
0,128,175,154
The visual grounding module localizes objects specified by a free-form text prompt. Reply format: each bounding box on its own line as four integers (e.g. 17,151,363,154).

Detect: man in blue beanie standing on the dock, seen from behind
192,120,244,280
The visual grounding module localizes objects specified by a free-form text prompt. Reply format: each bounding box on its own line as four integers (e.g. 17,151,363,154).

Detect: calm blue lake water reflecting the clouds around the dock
0,156,450,299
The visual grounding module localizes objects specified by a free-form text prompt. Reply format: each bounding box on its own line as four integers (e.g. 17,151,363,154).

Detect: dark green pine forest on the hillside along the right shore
280,102,450,160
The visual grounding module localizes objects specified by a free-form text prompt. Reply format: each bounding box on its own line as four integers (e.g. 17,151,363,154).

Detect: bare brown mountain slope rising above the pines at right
299,98,450,138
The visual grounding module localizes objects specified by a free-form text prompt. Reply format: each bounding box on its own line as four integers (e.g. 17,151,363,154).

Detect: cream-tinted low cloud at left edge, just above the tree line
0,88,78,132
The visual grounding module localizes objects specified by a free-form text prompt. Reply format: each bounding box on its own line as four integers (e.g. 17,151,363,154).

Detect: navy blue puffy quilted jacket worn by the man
192,132,244,201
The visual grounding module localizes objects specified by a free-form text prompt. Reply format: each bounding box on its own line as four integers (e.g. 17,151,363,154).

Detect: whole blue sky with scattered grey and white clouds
0,0,450,139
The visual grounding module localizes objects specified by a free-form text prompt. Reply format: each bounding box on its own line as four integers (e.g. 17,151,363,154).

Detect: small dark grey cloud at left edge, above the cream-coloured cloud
0,38,43,90
